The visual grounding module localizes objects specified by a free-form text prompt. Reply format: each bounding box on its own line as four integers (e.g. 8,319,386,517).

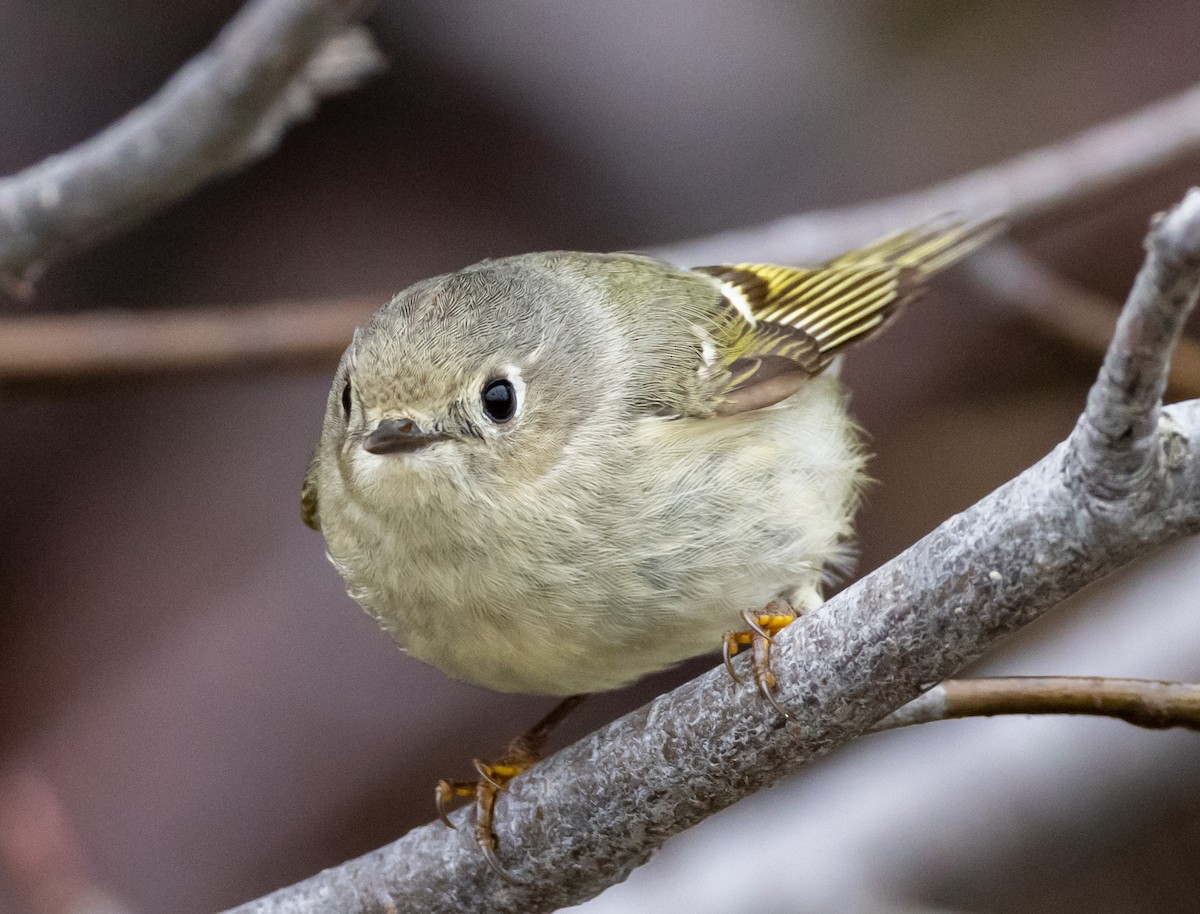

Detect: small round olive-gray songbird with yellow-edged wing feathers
302,221,992,864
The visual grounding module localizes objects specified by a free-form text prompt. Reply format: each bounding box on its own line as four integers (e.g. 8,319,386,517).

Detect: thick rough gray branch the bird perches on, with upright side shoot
216,191,1200,914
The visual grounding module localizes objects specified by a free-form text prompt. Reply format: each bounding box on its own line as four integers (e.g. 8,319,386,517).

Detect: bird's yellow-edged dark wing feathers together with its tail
695,221,998,415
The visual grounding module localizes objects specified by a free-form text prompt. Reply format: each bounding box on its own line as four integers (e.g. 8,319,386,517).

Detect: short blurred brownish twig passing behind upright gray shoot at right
966,243,1200,398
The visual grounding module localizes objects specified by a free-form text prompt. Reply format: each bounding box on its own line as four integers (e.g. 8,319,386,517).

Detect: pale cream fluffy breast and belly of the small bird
326,378,863,694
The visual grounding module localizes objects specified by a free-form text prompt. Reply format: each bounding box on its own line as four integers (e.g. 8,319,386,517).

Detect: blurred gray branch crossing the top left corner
0,0,382,291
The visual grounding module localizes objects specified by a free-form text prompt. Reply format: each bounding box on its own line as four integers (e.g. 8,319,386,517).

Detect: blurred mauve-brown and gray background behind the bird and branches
0,0,1200,914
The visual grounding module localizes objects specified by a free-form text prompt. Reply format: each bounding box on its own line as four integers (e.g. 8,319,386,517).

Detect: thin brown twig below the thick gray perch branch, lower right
871,677,1200,730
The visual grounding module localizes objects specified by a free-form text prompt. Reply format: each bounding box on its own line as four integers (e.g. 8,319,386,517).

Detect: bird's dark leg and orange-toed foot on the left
436,694,587,883
